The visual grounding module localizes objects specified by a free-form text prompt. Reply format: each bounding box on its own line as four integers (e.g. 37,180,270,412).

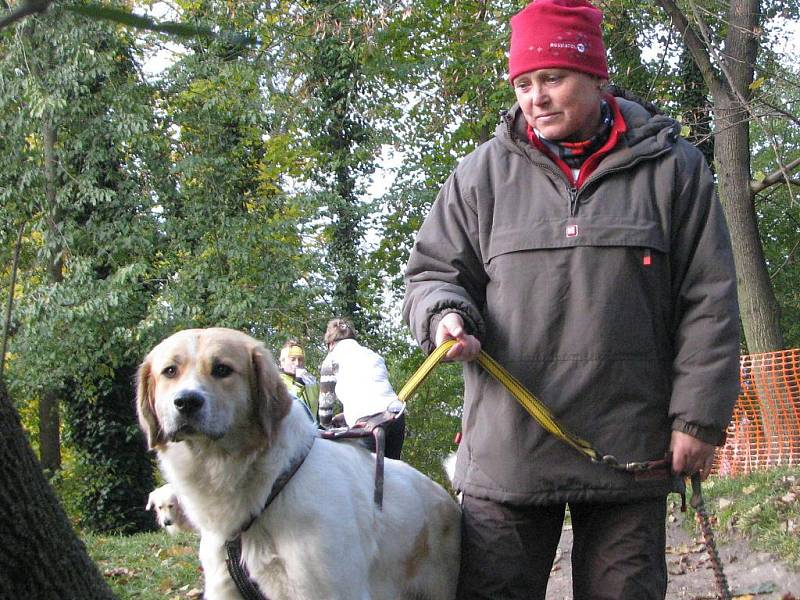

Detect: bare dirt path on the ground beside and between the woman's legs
547,502,800,600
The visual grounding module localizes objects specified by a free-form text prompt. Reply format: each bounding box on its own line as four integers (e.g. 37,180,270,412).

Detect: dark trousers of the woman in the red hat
457,495,667,600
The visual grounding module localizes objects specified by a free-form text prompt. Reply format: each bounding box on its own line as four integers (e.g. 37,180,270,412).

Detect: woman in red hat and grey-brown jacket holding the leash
403,0,739,600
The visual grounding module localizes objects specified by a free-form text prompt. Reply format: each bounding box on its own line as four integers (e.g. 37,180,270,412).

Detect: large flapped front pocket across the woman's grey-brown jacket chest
485,219,672,357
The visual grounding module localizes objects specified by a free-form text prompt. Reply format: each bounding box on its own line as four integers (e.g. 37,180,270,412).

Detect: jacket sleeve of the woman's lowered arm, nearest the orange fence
670,144,740,444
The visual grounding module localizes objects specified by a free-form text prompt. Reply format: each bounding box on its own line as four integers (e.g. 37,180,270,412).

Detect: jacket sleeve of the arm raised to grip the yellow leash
403,171,487,352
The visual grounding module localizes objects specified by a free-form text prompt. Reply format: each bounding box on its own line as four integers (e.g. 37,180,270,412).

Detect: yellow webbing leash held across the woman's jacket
397,340,600,466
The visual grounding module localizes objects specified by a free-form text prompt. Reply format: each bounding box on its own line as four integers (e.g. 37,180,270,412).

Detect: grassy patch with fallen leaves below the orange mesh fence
687,467,800,567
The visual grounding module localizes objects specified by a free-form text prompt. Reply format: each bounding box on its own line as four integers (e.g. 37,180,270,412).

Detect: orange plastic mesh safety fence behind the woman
714,348,800,476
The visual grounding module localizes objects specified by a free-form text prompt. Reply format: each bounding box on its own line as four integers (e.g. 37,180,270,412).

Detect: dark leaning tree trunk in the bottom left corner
0,380,114,600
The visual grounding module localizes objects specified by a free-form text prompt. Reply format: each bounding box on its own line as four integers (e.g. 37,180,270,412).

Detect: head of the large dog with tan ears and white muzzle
136,328,292,449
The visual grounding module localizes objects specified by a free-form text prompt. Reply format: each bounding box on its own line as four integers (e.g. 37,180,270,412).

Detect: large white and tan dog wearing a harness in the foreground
136,328,461,600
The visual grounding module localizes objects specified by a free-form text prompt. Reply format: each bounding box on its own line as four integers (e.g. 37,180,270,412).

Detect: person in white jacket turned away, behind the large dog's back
319,318,406,459
